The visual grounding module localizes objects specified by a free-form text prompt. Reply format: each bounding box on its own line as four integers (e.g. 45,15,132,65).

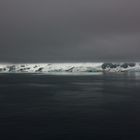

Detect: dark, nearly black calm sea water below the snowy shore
0,73,140,140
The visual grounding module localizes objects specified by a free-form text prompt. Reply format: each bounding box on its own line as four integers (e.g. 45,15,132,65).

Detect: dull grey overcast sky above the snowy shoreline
0,0,140,62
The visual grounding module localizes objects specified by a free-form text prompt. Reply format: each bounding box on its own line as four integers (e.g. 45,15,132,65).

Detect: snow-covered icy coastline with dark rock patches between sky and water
0,62,140,74
